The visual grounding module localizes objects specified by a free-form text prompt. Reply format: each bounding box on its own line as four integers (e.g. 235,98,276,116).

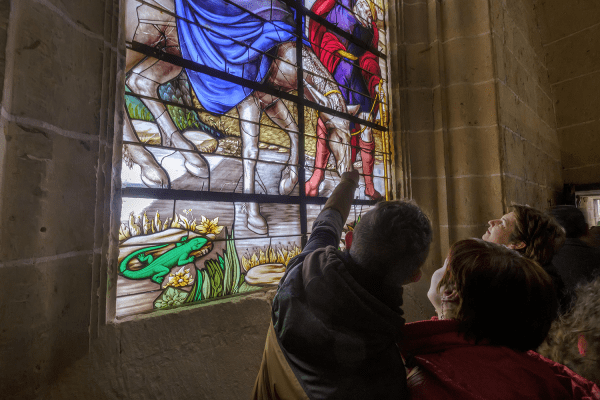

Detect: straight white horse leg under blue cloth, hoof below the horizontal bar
237,95,269,235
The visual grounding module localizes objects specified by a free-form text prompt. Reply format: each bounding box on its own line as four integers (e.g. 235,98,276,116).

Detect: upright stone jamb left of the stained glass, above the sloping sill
0,0,124,398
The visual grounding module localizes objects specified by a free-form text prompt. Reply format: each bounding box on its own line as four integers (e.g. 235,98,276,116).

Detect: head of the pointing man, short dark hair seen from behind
350,200,433,286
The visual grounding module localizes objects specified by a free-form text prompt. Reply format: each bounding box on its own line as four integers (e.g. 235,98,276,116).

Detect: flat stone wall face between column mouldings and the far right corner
490,0,562,209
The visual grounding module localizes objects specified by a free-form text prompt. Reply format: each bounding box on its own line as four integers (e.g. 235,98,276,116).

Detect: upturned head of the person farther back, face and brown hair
482,204,565,265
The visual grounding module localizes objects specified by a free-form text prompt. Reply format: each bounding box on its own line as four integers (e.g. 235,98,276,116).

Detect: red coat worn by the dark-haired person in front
399,318,600,400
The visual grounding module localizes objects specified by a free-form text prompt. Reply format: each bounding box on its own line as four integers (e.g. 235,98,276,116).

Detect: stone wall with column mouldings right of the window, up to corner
398,0,563,310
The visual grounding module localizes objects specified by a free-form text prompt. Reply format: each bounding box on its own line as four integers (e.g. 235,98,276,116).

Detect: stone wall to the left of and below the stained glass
0,0,270,400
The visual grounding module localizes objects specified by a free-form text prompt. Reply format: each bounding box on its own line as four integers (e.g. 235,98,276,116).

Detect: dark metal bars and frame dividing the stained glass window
105,0,399,321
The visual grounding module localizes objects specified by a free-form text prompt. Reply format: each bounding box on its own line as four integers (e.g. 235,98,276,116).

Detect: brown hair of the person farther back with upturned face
509,204,565,265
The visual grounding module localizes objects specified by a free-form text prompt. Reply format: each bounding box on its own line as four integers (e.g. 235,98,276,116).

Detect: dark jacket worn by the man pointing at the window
253,198,406,400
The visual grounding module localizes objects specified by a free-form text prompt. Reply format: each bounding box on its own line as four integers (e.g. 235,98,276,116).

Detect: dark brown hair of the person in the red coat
437,239,558,351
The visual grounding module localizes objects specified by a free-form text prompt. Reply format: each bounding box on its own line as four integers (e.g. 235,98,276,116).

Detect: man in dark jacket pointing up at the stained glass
252,171,432,400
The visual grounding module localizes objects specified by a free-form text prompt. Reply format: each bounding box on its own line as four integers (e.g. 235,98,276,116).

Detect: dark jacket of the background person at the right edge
552,238,600,292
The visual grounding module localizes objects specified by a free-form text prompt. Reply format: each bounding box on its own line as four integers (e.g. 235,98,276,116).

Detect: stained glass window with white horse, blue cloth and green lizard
117,0,392,317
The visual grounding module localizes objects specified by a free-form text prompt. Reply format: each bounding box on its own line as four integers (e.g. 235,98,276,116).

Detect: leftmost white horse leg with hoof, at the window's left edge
123,103,169,188
